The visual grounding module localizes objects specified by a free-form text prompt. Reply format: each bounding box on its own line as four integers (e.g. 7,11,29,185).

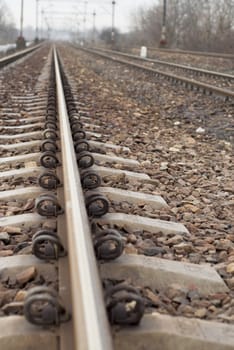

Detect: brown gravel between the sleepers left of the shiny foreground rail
0,46,58,316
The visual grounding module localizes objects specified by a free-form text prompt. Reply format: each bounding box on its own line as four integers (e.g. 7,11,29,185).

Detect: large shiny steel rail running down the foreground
54,48,112,350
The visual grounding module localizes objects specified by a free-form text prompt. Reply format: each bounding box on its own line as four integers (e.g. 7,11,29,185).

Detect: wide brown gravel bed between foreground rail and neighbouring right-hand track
60,44,234,323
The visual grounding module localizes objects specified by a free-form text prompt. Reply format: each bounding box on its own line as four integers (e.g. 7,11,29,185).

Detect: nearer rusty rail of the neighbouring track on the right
80,47,234,99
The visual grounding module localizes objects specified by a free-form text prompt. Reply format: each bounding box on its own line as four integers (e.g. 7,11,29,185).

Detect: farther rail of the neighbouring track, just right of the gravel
93,48,234,80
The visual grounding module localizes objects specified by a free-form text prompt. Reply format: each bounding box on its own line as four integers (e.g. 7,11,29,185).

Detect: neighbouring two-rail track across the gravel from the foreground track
81,49,234,99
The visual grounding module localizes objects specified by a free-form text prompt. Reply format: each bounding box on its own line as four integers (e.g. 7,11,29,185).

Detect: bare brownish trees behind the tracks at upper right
127,0,234,52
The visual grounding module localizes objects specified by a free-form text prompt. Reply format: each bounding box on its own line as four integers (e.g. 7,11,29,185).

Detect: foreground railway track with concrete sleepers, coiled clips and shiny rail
0,47,234,350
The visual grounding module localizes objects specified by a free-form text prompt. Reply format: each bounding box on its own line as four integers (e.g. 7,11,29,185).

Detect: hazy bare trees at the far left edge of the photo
0,0,17,44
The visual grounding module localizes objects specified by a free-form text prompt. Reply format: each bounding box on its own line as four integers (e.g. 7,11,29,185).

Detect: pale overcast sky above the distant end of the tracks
5,0,158,31
